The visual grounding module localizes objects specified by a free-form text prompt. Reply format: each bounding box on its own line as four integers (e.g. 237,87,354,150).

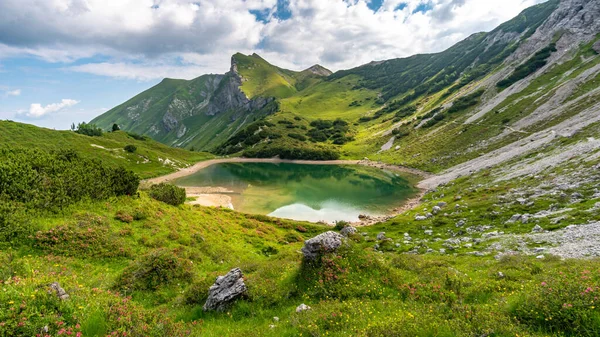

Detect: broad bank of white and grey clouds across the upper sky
0,0,544,76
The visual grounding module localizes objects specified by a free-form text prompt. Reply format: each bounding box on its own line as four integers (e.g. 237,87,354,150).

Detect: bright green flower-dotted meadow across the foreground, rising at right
0,117,600,337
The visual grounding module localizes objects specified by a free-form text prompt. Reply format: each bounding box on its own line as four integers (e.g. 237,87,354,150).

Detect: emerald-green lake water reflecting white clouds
175,163,416,222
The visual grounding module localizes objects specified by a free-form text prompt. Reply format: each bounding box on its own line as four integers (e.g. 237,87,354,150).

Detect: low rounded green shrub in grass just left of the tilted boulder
115,249,192,291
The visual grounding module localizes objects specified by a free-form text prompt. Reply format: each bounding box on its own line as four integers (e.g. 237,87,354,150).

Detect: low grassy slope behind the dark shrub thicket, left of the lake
0,121,212,178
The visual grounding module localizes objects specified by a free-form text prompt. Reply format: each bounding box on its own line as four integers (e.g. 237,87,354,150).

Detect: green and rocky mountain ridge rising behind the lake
92,0,600,171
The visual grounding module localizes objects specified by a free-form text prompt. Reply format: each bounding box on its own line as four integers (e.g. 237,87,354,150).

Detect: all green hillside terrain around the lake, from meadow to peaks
0,0,600,337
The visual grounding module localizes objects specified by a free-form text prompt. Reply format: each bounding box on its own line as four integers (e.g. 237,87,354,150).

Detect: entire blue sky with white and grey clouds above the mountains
0,0,544,129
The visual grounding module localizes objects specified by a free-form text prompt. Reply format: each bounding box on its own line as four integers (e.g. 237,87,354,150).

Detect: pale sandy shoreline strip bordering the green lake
142,157,435,227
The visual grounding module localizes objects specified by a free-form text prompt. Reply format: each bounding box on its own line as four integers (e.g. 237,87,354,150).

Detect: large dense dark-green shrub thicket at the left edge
0,148,140,211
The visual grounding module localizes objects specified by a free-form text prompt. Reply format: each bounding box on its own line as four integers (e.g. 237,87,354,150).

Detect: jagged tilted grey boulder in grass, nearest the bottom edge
203,268,248,311
